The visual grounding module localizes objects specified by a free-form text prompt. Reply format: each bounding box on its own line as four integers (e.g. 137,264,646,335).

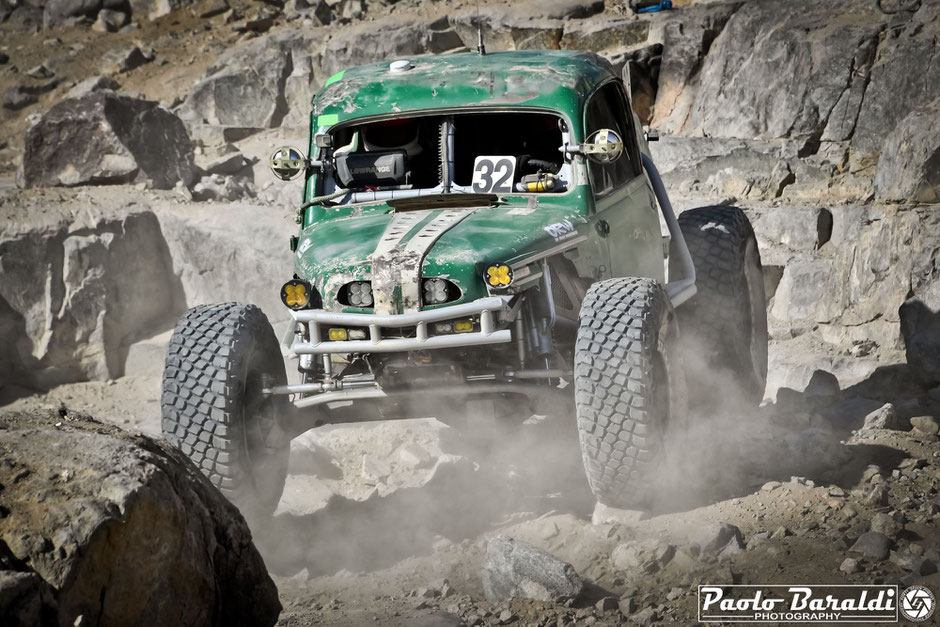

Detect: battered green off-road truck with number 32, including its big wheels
163,51,767,514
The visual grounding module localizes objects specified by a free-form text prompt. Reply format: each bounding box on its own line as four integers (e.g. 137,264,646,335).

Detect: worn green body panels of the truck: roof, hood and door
296,51,664,313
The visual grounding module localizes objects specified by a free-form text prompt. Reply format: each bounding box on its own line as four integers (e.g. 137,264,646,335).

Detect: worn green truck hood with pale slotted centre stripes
296,197,587,314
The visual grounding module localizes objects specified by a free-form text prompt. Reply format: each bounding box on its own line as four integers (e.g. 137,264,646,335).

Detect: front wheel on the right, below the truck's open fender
574,278,685,509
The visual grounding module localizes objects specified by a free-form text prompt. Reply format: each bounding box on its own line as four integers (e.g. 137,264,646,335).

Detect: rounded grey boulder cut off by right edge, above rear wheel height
875,97,940,202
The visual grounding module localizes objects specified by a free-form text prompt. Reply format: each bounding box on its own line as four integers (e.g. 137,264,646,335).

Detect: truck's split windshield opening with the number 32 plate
317,112,571,204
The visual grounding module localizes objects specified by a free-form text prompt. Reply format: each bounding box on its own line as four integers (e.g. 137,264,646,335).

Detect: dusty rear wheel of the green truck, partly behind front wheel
678,207,767,405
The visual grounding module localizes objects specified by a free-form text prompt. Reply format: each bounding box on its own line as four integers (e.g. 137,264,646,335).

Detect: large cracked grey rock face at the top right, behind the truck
682,0,880,139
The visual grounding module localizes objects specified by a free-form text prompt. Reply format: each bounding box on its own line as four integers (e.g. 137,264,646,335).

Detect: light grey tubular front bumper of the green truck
281,295,513,358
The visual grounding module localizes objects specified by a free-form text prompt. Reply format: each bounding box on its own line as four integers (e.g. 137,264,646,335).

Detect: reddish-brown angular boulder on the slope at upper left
23,90,196,189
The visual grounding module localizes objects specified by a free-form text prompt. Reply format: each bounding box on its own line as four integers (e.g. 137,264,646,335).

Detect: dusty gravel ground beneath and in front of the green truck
3,366,940,625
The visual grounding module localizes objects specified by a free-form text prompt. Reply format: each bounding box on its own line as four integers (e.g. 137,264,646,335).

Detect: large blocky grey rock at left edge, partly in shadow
0,210,182,385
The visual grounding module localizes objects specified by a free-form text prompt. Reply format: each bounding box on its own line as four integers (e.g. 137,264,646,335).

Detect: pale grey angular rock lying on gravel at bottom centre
483,535,584,603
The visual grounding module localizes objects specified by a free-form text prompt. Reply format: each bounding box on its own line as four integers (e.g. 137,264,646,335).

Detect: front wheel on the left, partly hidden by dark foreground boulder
162,303,290,517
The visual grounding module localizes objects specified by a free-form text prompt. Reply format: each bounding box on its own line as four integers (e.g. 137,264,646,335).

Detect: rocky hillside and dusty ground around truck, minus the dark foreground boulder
0,0,940,625
